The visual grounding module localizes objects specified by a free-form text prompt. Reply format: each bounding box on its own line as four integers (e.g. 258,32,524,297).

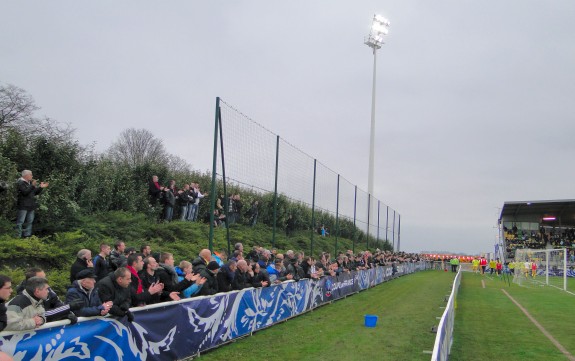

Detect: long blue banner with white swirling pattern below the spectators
0,264,425,361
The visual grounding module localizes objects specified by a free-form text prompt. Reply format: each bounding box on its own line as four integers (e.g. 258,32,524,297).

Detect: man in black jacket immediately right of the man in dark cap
96,267,134,322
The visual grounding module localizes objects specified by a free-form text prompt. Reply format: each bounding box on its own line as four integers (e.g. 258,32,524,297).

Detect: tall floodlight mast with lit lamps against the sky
364,14,389,200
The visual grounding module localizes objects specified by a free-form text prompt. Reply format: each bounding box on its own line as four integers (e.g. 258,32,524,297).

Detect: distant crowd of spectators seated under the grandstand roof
503,225,575,258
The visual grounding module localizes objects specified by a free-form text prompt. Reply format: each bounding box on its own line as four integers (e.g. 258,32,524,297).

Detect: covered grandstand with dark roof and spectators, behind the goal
499,200,575,264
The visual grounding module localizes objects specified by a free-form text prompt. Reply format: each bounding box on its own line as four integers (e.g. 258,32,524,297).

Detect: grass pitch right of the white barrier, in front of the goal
449,272,575,361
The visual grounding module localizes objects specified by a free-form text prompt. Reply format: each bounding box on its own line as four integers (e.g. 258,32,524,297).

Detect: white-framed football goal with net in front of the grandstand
510,248,568,291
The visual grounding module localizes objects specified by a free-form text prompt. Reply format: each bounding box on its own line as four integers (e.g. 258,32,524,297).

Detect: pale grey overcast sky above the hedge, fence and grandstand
0,0,575,253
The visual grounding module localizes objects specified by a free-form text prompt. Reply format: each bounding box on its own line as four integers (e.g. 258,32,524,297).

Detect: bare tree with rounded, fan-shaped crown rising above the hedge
108,128,169,167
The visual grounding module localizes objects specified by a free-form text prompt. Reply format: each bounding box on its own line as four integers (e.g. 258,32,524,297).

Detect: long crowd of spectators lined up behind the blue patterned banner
0,241,422,338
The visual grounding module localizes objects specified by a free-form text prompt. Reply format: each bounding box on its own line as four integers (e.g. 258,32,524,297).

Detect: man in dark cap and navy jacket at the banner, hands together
66,268,113,317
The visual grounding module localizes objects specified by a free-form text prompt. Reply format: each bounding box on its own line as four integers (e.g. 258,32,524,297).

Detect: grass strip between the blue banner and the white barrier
205,271,454,361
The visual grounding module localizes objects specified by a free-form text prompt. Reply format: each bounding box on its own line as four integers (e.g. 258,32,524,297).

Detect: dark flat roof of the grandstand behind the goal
499,199,575,226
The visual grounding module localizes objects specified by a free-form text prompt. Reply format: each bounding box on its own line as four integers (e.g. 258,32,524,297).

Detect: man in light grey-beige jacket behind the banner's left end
5,277,48,331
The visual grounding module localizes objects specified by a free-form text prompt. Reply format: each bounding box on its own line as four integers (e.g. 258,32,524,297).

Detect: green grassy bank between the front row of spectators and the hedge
0,212,366,297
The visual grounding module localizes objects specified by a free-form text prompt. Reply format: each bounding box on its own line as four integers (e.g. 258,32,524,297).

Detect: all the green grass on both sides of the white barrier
201,271,575,361
